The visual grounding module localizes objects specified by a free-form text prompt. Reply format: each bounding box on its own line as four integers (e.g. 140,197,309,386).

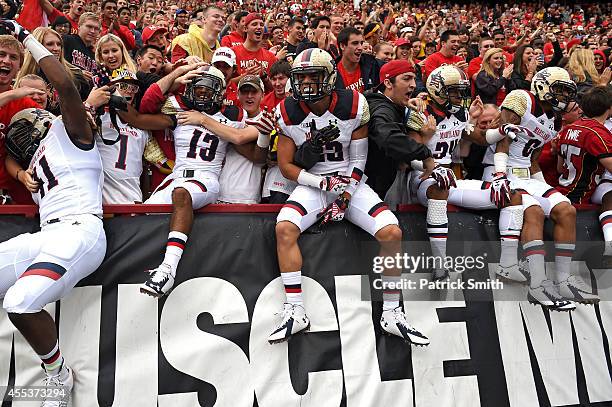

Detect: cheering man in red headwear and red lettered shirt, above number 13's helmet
232,13,276,89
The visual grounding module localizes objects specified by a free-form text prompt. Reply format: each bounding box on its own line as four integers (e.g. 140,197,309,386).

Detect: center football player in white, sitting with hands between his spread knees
268,48,429,345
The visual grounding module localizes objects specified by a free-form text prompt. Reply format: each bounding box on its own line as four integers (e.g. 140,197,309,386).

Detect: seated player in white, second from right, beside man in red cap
410,65,526,281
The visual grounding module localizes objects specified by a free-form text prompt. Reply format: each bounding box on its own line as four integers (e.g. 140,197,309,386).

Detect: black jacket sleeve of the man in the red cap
368,106,431,163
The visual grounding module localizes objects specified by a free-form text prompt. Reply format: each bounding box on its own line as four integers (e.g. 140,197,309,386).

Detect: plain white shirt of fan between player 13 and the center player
218,113,263,203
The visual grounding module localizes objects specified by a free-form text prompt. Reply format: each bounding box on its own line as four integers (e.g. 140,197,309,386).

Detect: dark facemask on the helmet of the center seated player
289,67,334,102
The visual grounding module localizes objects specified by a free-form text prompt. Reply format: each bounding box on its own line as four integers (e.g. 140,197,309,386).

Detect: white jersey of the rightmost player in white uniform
484,90,557,168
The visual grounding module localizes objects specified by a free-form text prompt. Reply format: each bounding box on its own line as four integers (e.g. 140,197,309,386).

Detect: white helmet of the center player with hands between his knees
289,48,337,102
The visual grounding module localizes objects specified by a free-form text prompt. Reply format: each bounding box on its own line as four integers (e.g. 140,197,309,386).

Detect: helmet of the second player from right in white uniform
426,65,471,114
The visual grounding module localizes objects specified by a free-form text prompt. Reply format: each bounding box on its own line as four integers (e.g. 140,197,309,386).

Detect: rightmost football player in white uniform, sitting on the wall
483,67,577,311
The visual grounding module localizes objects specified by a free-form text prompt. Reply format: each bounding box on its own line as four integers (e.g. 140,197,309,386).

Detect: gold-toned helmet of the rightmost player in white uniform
531,66,577,112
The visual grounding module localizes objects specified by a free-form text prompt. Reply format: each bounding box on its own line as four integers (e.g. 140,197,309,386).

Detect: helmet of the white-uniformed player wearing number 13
183,65,230,114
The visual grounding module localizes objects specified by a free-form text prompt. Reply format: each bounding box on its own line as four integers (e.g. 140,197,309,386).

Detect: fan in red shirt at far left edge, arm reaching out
0,35,44,205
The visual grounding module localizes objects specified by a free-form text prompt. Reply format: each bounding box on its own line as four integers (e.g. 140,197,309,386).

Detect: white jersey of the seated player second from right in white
425,108,469,164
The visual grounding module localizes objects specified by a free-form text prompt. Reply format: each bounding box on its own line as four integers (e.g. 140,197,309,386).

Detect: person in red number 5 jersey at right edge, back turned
557,87,612,204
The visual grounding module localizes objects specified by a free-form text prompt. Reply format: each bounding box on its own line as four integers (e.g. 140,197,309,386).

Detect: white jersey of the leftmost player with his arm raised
30,118,104,224
